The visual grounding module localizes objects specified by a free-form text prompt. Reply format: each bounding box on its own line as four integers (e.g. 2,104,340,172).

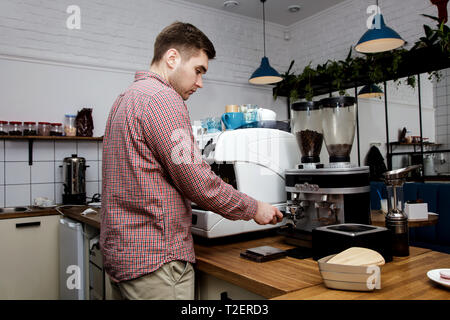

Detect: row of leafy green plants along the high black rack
273,14,450,101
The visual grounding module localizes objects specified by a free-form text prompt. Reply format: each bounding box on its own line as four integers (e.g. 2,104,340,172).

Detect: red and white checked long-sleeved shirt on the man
100,71,257,281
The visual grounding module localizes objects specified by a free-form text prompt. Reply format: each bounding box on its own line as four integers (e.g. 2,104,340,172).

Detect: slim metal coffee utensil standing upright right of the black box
383,165,422,257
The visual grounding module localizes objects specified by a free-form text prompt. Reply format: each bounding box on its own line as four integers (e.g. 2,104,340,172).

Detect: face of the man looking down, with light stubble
169,50,208,100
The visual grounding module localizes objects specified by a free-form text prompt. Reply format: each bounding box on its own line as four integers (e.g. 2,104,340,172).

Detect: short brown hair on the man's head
151,21,216,65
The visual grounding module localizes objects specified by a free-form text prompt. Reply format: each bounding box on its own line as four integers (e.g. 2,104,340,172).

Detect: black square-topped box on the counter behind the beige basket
312,223,392,262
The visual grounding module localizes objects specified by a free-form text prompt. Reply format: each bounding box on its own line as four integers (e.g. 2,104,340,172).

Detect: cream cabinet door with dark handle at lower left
0,215,60,300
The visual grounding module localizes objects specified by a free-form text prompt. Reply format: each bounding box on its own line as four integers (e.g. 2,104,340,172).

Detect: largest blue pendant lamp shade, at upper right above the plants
355,13,405,53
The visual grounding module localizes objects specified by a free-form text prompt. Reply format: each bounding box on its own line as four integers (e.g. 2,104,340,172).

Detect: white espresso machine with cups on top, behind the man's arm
191,128,300,238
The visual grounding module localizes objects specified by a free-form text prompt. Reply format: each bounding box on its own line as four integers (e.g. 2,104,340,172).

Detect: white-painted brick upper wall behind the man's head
0,0,289,84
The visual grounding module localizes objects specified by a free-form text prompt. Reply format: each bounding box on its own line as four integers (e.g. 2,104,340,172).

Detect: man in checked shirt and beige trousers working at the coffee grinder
100,22,282,299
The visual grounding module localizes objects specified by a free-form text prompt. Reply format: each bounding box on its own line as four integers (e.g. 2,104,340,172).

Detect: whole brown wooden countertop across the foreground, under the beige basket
195,236,450,300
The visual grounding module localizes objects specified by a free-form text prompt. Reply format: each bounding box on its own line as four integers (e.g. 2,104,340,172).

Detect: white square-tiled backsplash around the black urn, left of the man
0,140,102,207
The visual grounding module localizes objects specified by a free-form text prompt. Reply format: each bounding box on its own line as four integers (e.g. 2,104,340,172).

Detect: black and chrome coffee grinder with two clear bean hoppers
280,96,370,248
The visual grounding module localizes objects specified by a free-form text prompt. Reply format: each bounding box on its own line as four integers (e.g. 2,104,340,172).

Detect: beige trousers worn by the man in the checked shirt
111,261,195,300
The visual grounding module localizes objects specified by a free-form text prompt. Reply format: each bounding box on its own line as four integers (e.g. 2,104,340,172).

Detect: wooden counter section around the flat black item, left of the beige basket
195,236,322,298
